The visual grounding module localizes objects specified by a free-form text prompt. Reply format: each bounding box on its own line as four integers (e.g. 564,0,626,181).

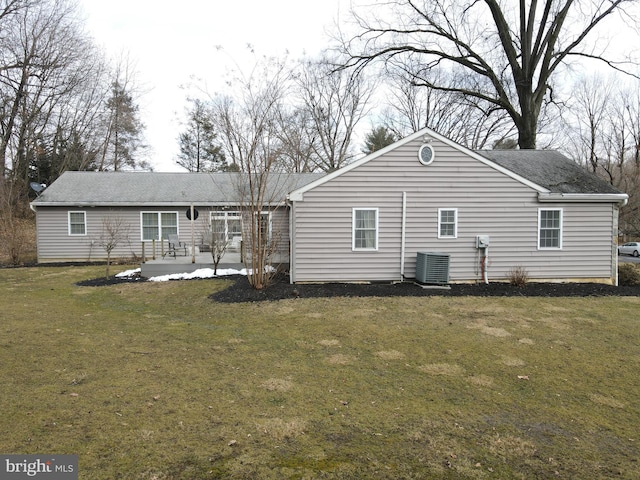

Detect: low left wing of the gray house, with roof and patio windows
31,171,322,263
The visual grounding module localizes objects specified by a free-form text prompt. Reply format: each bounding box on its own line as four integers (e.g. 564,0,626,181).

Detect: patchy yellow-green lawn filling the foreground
0,267,640,480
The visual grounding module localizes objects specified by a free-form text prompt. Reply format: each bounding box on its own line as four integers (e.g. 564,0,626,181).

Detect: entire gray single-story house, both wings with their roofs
32,129,628,284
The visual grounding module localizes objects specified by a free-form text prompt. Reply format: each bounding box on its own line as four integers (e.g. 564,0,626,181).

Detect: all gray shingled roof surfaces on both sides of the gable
33,150,624,207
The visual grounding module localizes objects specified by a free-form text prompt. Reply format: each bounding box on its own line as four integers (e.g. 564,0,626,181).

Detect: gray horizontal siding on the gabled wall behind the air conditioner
293,137,615,282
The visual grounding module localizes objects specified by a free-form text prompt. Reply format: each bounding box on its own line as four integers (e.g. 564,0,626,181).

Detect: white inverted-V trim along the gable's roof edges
288,128,549,202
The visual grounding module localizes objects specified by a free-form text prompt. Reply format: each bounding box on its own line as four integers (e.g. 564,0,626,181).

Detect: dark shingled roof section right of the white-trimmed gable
476,150,622,194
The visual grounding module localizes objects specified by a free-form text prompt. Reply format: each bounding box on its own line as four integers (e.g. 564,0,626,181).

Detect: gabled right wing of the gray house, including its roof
289,129,628,284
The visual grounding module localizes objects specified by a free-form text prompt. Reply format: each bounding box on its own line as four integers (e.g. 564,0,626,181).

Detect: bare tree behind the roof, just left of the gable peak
296,58,374,172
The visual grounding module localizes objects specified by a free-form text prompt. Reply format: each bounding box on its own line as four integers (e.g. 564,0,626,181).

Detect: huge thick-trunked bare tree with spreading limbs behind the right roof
340,0,637,149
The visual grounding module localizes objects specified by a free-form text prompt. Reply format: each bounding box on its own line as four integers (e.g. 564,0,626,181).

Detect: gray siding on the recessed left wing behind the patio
36,206,289,263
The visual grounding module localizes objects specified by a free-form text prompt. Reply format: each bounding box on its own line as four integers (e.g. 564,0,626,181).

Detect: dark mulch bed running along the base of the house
78,275,640,303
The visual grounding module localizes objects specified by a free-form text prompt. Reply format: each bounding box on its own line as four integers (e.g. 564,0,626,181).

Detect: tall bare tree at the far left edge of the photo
0,0,95,184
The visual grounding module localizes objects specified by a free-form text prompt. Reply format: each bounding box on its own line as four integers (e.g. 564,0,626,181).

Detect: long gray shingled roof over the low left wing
33,172,322,206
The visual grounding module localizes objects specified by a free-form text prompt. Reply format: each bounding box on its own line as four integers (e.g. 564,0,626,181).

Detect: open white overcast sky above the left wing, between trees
81,0,348,172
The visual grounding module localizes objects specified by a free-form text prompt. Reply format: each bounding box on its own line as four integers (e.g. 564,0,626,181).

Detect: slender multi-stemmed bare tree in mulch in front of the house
213,58,290,290
